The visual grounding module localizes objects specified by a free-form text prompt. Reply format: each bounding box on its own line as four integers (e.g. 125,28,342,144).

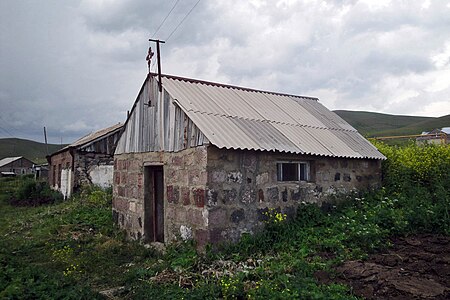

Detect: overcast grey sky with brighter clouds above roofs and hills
0,0,450,143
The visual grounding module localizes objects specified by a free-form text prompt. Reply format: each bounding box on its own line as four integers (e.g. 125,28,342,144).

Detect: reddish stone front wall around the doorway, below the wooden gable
113,146,208,242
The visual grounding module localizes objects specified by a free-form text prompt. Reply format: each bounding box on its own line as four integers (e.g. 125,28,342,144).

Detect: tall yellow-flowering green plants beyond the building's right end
375,142,450,234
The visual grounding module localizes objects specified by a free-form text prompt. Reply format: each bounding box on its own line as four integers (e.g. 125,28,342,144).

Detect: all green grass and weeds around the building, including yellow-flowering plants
0,144,450,299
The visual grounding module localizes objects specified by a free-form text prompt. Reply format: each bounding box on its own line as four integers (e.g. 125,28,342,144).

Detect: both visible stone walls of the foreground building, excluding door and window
113,146,381,246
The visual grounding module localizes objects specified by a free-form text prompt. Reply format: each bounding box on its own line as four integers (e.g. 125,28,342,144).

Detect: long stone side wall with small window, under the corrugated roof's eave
207,147,381,243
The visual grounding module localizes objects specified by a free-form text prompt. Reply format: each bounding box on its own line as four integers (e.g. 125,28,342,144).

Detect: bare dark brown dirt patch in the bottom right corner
328,235,450,299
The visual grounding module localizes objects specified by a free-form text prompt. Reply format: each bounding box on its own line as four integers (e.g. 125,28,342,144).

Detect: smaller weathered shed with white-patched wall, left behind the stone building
47,123,122,197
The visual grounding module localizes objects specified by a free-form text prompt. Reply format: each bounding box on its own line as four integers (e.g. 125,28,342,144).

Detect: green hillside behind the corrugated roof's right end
334,110,450,137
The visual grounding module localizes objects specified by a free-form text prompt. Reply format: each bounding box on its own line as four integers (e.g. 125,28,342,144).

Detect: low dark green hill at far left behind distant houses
0,138,66,163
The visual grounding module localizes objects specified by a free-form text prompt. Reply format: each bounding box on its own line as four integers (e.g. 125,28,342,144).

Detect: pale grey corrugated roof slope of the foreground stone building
163,75,385,159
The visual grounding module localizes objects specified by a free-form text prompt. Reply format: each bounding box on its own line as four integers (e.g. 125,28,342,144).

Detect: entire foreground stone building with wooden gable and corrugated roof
113,74,385,246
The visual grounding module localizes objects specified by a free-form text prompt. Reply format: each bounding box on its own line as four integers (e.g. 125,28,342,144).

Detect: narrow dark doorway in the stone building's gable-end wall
144,166,164,243
